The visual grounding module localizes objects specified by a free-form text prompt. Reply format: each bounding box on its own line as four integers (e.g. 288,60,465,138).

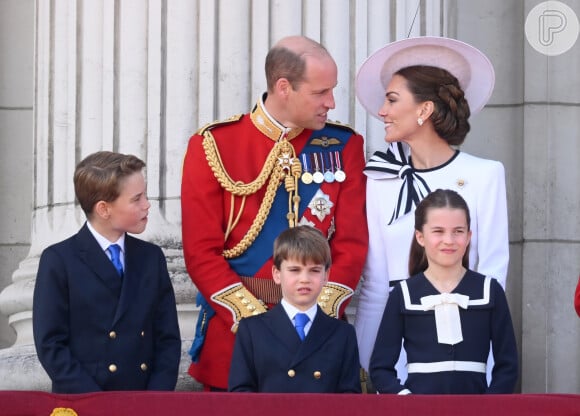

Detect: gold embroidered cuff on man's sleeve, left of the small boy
211,283,267,334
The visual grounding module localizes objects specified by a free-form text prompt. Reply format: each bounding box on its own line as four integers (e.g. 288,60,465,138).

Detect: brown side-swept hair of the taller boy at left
73,151,145,217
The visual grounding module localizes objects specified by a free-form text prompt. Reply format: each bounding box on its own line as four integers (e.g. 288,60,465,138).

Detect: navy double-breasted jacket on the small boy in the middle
228,304,361,393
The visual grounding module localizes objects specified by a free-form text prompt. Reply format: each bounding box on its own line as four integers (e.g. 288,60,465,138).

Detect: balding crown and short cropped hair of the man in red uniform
265,36,330,91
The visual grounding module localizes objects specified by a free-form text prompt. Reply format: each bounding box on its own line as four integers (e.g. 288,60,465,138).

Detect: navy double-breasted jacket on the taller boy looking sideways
32,224,181,393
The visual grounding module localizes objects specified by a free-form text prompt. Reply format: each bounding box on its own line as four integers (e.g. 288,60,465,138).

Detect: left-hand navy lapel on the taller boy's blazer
76,223,121,294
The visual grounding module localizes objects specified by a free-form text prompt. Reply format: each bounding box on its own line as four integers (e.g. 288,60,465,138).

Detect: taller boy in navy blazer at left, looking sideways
32,151,181,393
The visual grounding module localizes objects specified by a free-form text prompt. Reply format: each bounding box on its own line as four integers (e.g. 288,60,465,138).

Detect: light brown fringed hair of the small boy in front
273,225,332,270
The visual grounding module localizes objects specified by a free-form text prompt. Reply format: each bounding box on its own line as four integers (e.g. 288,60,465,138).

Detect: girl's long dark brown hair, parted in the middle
409,189,471,276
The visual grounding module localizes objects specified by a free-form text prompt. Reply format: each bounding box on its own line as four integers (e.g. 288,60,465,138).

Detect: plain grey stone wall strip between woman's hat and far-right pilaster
448,0,524,391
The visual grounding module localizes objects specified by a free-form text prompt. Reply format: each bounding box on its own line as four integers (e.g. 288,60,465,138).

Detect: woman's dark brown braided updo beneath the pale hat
395,65,471,145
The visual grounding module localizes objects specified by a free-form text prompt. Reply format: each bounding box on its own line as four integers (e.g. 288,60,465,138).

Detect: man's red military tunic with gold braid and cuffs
181,96,368,389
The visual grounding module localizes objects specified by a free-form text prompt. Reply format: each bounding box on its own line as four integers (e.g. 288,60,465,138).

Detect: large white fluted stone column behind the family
0,0,444,390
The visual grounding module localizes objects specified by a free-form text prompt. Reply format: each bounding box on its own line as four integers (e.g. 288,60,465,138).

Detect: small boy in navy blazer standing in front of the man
228,225,361,393
